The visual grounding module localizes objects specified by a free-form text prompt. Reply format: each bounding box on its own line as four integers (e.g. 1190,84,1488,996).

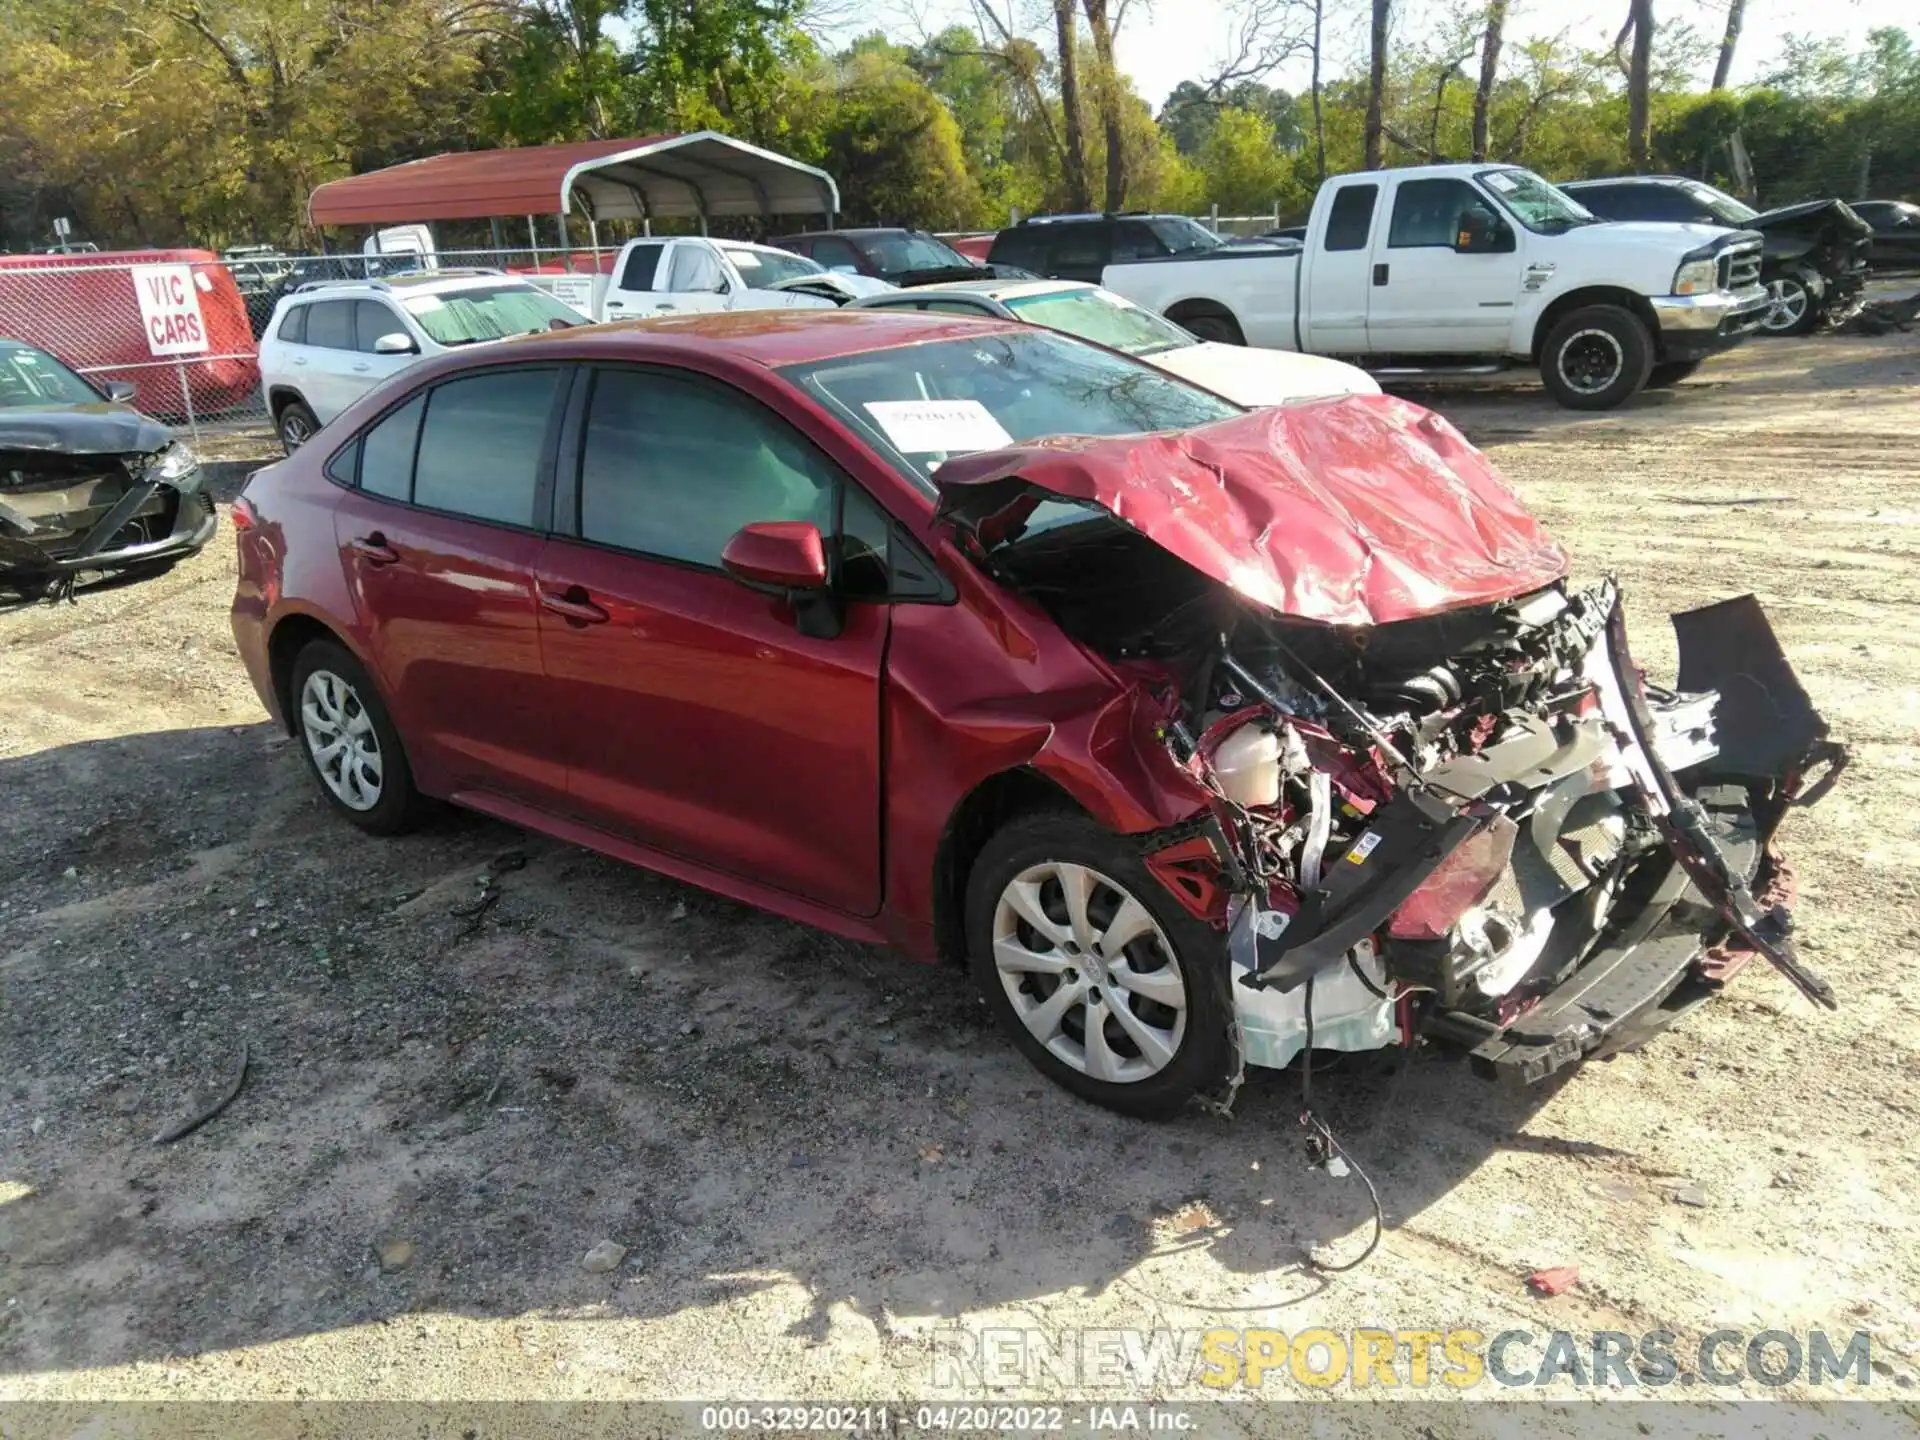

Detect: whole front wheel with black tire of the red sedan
966,810,1233,1119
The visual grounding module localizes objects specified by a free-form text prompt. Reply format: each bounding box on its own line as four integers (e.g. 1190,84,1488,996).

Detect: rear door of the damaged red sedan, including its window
334,367,566,810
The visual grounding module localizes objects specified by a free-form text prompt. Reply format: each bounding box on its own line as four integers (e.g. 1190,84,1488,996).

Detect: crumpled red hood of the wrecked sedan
935,396,1567,626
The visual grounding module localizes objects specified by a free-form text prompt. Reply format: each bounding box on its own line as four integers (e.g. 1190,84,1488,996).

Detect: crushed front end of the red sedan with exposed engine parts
1167,580,1845,1081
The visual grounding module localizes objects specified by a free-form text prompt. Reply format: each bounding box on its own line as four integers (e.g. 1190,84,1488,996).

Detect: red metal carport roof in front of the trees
307,131,839,227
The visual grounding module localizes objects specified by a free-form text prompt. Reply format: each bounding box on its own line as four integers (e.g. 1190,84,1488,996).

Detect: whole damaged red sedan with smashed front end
232,311,1843,1116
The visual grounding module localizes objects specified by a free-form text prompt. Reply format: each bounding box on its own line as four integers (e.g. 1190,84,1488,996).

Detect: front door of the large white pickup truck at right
1367,179,1521,355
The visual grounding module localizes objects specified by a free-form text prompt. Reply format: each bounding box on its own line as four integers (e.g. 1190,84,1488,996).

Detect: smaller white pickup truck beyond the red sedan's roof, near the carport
520,234,893,321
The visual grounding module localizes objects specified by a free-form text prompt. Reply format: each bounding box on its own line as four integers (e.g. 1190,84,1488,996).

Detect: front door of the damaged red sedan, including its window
538,369,889,914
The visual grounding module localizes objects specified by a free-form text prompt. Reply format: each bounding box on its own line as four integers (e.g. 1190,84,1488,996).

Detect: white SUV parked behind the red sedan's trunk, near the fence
259,271,586,453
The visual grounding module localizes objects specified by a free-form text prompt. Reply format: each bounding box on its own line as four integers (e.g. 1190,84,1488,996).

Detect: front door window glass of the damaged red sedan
580,371,839,568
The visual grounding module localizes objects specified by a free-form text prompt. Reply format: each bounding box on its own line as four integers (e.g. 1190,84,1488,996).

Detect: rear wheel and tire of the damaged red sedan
288,639,422,835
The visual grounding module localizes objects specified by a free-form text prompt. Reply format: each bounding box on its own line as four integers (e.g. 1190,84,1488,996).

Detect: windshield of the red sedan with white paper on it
781,328,1242,490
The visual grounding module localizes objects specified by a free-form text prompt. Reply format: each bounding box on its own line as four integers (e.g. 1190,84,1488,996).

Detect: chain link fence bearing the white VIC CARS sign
0,248,618,442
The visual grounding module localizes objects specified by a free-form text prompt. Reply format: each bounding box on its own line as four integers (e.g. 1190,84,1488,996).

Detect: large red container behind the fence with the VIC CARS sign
0,250,259,419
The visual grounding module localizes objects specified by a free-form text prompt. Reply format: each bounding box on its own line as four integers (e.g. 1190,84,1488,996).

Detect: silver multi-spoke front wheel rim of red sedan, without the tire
993,860,1187,1085
